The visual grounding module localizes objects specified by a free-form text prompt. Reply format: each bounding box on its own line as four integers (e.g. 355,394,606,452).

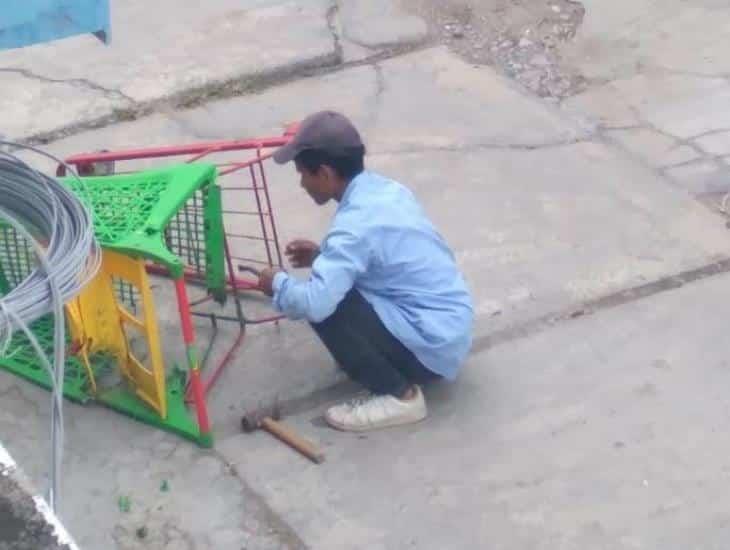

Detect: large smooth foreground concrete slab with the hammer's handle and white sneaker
221,275,730,550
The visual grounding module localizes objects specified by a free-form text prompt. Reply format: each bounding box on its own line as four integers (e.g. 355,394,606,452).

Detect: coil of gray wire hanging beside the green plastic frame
0,141,101,510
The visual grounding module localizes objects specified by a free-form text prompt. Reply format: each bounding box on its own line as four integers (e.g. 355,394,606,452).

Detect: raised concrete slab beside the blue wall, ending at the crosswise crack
0,0,341,139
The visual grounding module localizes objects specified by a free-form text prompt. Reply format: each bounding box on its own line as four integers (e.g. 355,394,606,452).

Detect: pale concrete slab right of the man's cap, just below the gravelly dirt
368,48,588,152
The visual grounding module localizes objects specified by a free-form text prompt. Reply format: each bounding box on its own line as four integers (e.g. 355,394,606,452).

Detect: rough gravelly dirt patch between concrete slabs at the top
401,0,586,99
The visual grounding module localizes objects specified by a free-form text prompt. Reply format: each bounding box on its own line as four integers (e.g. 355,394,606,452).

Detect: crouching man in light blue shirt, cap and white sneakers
259,111,474,431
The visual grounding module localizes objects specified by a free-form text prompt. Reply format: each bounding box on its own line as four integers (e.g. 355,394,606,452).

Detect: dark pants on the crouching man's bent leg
312,289,440,397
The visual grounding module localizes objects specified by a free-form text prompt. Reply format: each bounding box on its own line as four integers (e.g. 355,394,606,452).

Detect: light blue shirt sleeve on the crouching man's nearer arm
273,230,370,323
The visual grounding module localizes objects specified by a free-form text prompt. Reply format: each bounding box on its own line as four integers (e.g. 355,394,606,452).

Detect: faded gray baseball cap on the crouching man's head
274,111,363,164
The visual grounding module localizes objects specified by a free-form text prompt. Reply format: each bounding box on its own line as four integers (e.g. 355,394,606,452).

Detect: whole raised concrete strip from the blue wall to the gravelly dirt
0,0,427,141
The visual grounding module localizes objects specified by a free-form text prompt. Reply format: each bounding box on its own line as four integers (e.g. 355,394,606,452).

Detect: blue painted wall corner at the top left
0,0,111,49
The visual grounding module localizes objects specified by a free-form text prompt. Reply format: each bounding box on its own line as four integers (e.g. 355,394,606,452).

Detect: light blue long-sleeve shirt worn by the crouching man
273,172,474,379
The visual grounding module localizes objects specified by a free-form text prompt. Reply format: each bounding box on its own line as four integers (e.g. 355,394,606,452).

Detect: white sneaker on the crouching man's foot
324,386,428,432
